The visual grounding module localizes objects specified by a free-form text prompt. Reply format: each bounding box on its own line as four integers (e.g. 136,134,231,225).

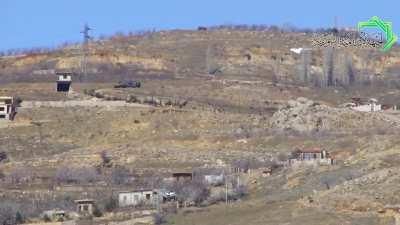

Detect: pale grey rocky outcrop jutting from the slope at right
270,98,400,132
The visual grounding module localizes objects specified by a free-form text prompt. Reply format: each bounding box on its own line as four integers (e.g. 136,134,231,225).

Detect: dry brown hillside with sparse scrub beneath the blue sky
0,29,400,225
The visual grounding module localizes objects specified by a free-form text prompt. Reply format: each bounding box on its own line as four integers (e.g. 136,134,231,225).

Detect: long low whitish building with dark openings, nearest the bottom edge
118,189,158,207
